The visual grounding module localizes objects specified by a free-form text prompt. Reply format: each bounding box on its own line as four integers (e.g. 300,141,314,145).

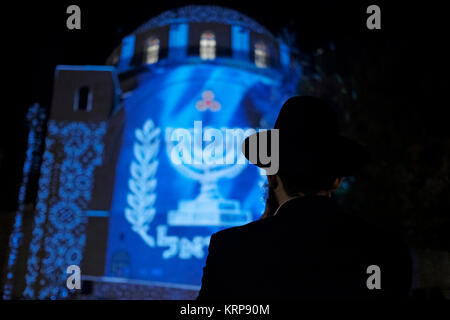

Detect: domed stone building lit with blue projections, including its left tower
5,6,301,299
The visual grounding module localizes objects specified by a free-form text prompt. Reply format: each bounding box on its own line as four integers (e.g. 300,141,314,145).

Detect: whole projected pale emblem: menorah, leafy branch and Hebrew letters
125,119,255,260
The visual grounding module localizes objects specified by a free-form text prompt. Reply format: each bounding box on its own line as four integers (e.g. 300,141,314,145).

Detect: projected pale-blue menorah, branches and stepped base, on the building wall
166,128,251,226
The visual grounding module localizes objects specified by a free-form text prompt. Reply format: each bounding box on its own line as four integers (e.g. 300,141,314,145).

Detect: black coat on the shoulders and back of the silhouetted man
198,196,411,300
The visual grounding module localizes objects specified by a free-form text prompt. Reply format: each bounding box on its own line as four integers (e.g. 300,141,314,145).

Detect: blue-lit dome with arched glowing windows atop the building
106,5,291,73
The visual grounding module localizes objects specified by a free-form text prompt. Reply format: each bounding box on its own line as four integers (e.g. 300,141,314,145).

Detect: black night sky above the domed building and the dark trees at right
0,0,448,211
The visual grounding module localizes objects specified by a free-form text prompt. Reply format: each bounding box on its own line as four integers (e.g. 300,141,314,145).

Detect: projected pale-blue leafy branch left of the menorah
125,119,161,247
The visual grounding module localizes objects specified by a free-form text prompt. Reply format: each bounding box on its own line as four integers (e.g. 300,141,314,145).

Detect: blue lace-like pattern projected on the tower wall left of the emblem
23,120,106,299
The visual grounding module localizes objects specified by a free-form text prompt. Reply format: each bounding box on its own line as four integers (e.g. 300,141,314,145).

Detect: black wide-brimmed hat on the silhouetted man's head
242,96,369,177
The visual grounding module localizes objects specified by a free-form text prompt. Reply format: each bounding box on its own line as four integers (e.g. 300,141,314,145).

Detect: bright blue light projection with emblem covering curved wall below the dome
105,61,285,286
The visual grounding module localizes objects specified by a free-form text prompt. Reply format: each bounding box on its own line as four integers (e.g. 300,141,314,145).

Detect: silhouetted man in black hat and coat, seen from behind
198,97,411,300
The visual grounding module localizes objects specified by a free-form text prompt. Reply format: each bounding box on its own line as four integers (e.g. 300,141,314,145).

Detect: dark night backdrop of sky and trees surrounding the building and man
0,0,450,294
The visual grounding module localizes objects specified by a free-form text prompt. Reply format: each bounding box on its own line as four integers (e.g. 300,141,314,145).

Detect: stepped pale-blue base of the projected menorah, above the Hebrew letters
167,199,251,226
